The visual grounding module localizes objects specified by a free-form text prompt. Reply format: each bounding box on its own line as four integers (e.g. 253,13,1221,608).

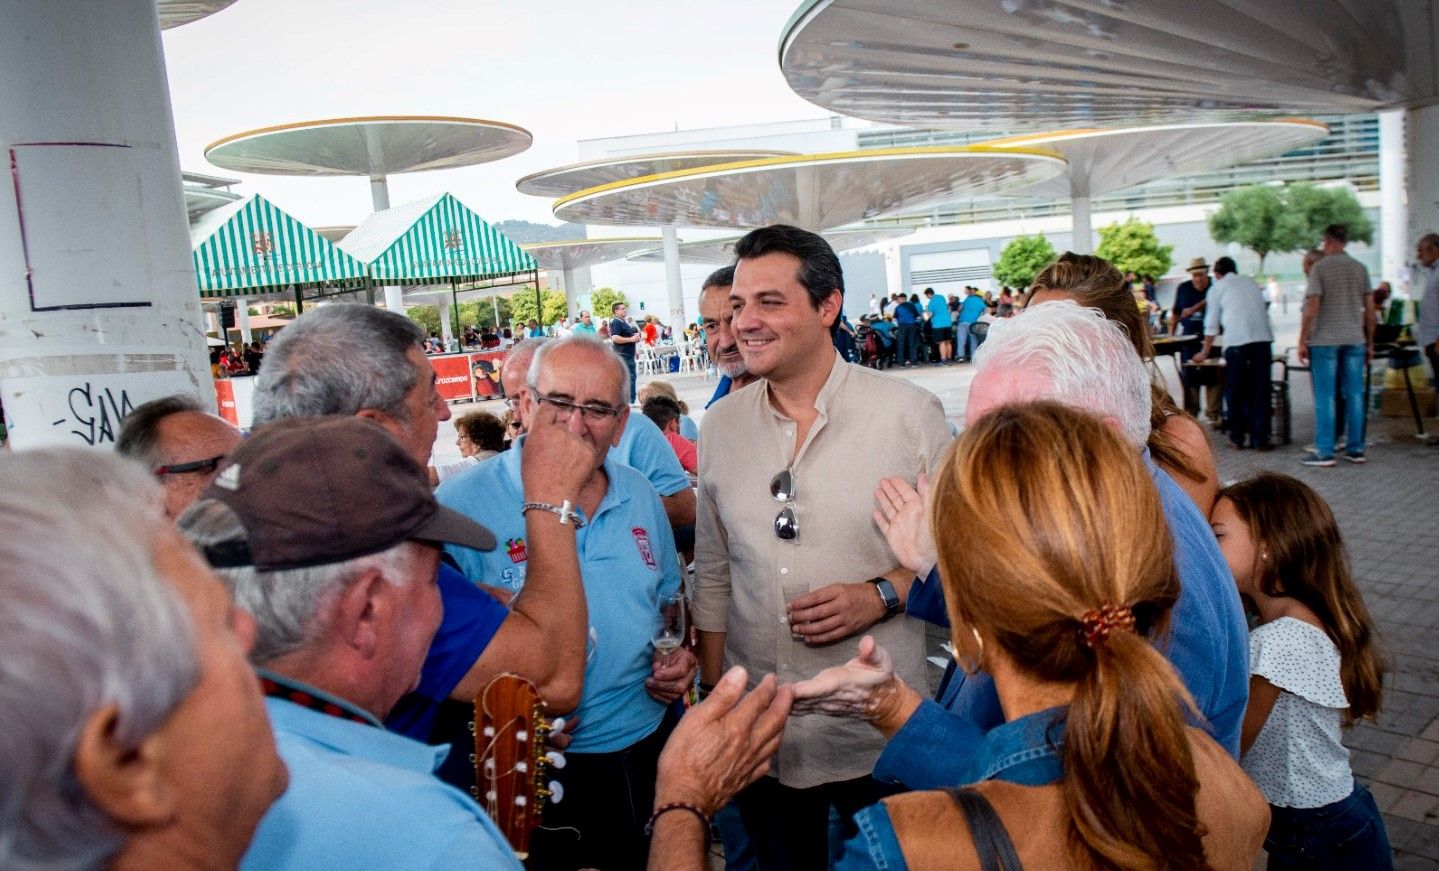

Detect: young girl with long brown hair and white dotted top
1210,472,1393,871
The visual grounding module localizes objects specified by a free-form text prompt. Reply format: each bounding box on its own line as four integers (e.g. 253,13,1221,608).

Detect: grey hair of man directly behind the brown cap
255,304,426,426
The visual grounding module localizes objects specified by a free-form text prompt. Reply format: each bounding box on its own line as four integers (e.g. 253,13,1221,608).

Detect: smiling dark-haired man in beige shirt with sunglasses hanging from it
694,226,950,870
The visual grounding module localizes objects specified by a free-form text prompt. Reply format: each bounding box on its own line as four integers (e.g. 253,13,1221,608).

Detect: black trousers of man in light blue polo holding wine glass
525,705,678,871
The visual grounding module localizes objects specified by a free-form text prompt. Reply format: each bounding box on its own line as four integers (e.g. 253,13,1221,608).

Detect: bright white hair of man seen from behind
974,299,1153,448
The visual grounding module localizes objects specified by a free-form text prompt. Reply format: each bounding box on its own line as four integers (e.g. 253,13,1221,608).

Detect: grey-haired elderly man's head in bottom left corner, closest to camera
0,449,285,870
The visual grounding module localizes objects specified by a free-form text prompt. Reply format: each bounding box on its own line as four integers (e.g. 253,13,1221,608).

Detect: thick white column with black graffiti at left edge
0,0,216,449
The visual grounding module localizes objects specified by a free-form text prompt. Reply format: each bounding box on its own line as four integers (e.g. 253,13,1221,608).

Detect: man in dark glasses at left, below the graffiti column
115,394,240,520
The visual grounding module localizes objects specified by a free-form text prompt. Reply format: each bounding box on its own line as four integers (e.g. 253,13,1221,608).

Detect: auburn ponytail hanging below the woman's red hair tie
1061,621,1209,871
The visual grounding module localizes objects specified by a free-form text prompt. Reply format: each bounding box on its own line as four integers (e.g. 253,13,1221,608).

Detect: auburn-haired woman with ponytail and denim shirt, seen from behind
650,402,1269,871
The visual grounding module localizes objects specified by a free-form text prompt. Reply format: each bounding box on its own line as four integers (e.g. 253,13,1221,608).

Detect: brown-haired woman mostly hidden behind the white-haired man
1025,251,1219,517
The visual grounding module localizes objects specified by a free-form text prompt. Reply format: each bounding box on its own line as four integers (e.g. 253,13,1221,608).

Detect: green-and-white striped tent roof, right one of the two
340,193,540,285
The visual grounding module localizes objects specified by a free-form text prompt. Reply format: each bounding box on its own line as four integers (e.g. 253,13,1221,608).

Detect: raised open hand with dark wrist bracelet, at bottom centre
655,667,793,816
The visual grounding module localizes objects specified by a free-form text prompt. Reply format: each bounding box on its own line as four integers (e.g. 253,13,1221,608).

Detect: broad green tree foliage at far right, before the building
1209,183,1374,272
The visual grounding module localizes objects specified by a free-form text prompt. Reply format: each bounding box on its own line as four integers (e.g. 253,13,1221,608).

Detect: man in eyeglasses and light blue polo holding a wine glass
435,335,696,870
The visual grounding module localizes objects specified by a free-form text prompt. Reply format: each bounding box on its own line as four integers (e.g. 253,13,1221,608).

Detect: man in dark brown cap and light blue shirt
180,416,519,870
